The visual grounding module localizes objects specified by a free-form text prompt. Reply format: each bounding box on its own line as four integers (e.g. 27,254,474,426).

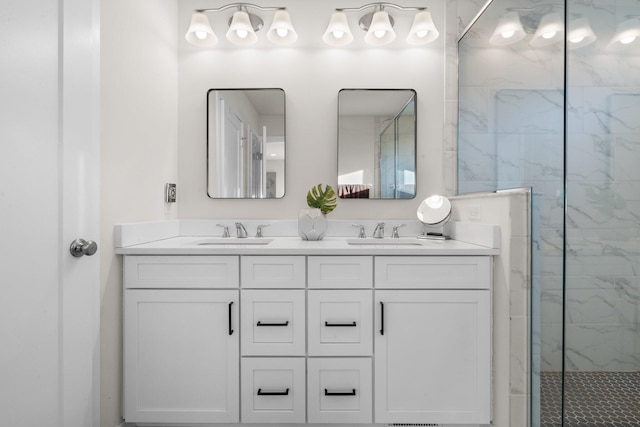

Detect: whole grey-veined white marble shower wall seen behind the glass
456,0,640,372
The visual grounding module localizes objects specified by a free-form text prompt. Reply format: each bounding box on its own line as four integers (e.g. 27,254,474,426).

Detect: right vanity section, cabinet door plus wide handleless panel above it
374,257,491,424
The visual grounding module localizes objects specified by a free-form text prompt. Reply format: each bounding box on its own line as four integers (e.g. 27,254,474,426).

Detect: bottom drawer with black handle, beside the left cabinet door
241,357,306,423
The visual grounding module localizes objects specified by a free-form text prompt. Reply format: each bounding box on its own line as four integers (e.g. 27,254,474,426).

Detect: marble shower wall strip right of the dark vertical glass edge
564,0,640,371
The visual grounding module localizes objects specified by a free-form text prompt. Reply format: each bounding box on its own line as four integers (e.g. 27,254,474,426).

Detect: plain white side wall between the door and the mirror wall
99,0,180,427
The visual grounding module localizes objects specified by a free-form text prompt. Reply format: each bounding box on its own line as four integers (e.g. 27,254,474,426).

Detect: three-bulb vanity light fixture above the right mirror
322,3,440,46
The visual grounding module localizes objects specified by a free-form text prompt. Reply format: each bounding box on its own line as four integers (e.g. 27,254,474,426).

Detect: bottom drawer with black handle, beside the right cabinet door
307,358,373,424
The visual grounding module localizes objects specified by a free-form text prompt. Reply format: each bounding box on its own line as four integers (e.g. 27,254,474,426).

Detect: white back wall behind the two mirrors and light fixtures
178,0,444,219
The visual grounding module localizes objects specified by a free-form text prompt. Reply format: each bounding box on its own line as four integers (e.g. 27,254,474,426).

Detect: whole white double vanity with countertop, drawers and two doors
116,221,499,425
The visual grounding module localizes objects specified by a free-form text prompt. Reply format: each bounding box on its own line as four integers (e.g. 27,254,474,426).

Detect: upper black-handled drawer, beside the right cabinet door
307,290,373,356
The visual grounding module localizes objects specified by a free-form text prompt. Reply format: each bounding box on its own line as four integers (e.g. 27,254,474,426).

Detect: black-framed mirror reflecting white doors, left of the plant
207,89,286,199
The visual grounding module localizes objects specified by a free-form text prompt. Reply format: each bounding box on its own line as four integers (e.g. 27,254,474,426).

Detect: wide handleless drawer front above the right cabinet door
375,256,491,289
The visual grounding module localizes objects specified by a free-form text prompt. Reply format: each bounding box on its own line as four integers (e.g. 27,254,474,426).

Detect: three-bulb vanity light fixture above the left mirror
185,3,298,47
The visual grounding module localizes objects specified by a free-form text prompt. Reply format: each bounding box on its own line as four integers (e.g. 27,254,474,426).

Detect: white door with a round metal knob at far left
0,0,100,427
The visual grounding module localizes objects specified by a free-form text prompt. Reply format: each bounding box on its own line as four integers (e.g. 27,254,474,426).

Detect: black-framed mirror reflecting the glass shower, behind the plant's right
338,89,417,199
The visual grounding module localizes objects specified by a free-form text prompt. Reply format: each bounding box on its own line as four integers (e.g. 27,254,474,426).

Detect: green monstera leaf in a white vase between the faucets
298,184,337,240
